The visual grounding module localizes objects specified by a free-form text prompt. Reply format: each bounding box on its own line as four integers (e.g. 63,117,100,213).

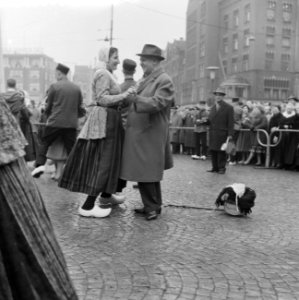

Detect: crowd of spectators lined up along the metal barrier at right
170,97,299,171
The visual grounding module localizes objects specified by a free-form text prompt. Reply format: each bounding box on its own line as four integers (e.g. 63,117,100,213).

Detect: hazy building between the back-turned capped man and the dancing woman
73,66,94,103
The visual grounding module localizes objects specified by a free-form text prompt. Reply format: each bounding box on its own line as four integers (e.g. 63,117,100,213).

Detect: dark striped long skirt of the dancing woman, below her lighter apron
59,109,124,196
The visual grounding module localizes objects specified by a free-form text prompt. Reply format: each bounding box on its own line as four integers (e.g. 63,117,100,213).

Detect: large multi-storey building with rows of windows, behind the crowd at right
183,0,299,104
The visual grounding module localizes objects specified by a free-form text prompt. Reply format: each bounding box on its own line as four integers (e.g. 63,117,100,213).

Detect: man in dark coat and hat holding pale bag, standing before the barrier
207,88,234,174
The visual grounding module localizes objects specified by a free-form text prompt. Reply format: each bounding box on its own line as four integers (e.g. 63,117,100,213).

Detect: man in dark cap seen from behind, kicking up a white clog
32,64,85,177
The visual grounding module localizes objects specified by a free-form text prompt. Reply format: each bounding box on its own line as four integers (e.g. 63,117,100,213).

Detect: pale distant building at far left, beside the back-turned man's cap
3,53,56,102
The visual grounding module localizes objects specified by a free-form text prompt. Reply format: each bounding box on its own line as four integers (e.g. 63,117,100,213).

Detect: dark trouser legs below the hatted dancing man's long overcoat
138,182,162,213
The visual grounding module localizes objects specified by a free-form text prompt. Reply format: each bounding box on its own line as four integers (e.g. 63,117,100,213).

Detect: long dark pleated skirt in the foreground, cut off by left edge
0,158,77,300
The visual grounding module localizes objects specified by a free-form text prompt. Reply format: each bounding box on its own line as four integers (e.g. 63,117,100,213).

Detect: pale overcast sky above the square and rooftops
0,0,188,76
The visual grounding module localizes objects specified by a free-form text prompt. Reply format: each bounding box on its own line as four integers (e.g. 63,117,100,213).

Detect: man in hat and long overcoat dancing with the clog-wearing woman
120,44,174,220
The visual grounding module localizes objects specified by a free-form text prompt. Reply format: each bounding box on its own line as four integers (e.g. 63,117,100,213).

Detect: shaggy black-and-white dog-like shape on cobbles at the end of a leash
215,183,256,216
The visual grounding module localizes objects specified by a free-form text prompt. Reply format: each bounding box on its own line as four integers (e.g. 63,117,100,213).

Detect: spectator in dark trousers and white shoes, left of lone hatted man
192,101,208,160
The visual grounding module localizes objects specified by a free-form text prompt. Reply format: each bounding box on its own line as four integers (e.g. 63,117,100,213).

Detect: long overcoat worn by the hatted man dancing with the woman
120,68,174,182
